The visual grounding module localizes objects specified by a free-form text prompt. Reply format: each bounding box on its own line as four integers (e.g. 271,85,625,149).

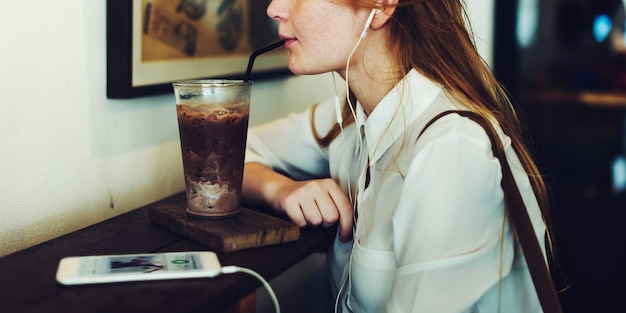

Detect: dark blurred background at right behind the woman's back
494,0,626,312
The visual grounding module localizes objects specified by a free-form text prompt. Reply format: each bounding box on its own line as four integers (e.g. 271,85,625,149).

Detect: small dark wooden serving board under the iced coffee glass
148,204,300,252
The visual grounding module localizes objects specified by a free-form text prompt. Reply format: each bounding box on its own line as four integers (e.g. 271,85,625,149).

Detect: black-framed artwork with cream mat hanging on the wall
107,0,289,99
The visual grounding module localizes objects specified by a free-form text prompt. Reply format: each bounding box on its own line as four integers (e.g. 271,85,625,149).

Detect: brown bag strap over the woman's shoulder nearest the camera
417,110,562,313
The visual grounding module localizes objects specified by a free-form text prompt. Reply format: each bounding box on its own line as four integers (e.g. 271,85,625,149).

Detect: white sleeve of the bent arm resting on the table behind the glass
246,97,334,179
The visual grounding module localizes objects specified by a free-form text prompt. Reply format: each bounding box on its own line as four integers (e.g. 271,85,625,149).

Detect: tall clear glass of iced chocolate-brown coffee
174,81,251,218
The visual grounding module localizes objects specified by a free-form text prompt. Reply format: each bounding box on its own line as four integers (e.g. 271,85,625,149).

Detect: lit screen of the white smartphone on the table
78,252,203,276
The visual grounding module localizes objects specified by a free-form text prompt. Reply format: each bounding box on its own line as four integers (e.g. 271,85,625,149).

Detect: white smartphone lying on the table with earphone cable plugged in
56,251,222,285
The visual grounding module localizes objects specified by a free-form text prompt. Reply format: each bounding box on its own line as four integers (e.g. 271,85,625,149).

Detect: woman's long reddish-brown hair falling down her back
316,0,556,282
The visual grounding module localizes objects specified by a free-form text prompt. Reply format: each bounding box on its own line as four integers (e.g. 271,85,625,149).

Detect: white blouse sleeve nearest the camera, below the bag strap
388,116,513,313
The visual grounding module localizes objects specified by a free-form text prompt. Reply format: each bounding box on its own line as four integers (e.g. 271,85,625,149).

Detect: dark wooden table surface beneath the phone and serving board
0,194,335,313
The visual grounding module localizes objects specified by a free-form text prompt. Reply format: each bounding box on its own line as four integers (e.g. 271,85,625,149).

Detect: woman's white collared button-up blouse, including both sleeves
246,70,545,313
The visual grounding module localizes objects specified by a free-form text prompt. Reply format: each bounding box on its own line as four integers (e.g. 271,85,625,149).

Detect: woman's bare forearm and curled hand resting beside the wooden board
242,163,353,242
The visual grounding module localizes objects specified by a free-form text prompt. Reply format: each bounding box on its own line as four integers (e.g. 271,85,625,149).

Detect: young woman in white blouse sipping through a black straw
243,0,546,312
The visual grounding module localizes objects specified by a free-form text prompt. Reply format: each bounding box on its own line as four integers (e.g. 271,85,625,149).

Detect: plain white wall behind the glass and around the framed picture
0,0,493,256
